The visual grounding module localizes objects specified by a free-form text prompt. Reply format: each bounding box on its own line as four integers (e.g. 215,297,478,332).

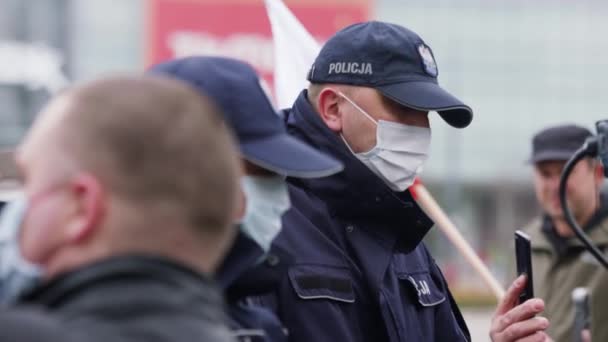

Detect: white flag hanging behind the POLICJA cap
264,0,321,109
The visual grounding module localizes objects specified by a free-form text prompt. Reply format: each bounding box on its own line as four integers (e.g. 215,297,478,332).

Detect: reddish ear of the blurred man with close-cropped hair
65,174,107,244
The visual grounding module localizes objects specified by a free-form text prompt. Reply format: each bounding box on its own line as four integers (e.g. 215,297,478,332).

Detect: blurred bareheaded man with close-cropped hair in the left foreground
0,76,239,342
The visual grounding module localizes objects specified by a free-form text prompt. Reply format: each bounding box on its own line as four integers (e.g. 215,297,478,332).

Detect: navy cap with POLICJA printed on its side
308,21,473,128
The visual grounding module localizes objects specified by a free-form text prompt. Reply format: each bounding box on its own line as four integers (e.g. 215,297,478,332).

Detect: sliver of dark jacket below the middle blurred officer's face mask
216,232,287,342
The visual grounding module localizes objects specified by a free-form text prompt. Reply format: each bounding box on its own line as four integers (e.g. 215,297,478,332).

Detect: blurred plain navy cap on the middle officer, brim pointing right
149,57,343,178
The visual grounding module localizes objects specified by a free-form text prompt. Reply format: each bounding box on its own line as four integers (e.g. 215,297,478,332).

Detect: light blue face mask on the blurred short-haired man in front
0,196,42,305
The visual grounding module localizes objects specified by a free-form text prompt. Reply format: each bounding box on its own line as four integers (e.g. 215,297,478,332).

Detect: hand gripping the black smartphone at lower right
490,275,551,342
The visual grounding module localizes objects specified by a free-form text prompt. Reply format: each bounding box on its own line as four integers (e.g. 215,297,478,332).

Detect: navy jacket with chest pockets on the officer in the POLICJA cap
260,91,470,342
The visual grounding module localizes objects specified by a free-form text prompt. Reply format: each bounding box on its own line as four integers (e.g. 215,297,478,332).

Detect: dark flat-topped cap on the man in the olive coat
529,125,593,163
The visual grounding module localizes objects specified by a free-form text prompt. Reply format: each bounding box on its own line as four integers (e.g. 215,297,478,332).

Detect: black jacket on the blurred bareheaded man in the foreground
0,256,232,342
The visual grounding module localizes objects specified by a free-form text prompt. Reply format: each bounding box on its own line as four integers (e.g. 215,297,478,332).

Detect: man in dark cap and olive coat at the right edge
524,124,608,342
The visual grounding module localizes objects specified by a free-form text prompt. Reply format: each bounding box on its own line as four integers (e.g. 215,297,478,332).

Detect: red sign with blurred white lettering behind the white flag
147,0,373,89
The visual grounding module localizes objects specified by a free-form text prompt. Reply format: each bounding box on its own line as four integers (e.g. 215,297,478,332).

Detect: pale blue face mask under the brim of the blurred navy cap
241,176,290,252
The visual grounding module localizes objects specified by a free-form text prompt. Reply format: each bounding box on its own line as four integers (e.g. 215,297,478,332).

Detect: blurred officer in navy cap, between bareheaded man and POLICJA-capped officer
150,57,342,341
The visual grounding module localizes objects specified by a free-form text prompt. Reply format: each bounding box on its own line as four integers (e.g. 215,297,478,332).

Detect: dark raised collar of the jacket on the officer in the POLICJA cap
284,90,433,250
